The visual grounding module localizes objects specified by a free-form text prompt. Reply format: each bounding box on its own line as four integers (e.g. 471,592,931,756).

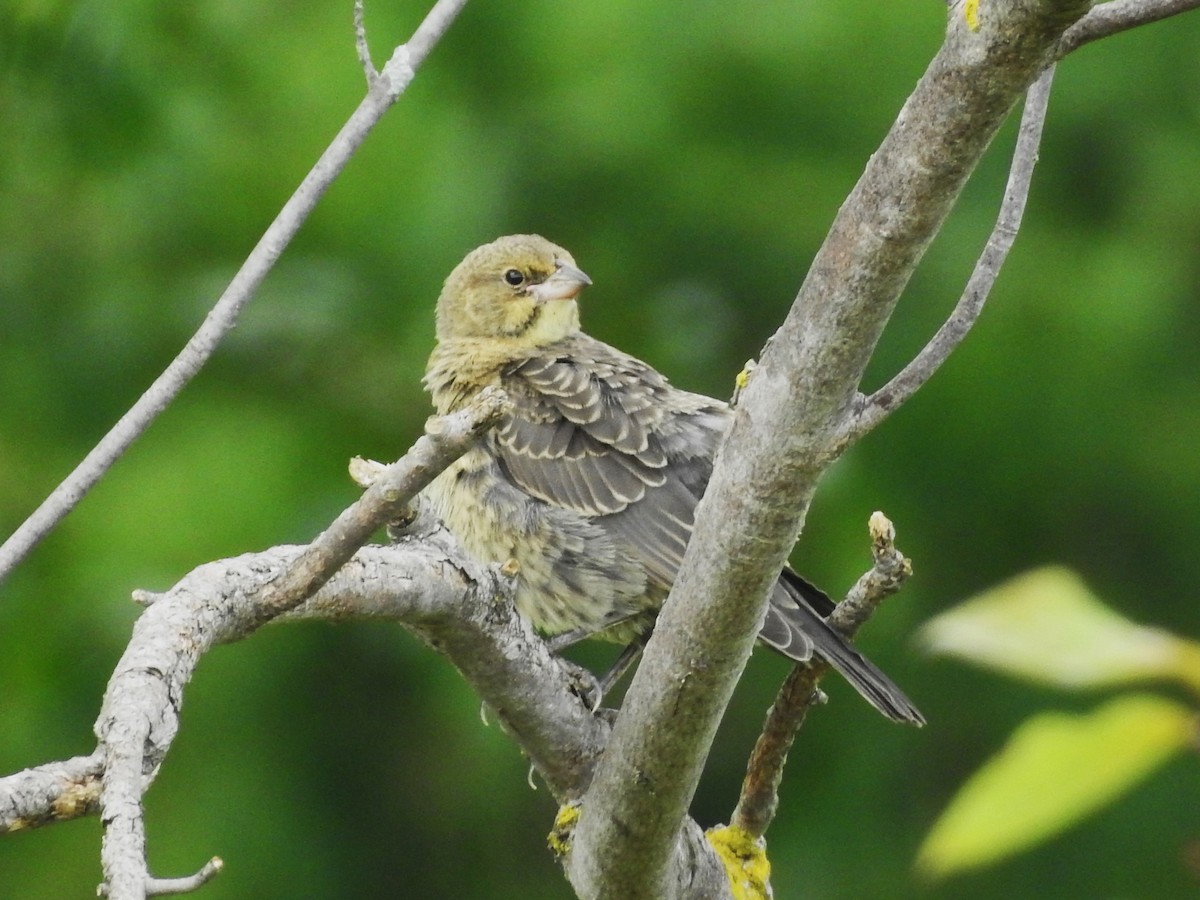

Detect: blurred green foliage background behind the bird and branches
0,0,1200,900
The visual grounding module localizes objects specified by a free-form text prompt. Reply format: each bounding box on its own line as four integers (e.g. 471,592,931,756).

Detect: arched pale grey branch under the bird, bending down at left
85,540,608,898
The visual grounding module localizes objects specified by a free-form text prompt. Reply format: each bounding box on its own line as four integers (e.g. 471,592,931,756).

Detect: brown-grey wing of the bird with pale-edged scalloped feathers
493,336,728,588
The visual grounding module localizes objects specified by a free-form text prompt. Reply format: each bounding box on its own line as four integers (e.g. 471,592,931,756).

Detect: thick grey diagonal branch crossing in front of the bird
568,0,1090,898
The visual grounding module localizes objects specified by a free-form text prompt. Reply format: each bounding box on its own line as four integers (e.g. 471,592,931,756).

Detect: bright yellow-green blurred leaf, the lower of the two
917,695,1195,877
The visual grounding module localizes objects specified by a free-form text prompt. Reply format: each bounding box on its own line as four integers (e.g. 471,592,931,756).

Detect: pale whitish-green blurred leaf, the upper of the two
922,566,1200,692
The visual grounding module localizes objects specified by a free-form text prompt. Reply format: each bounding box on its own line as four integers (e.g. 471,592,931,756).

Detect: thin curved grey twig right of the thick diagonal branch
839,65,1054,446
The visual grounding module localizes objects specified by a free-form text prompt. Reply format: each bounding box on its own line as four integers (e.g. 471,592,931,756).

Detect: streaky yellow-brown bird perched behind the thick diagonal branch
424,234,924,725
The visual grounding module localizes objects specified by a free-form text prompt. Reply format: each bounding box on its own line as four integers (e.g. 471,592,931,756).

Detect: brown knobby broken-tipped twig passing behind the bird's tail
731,512,912,838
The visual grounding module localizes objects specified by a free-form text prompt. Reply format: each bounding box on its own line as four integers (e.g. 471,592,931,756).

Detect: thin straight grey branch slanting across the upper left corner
0,0,467,592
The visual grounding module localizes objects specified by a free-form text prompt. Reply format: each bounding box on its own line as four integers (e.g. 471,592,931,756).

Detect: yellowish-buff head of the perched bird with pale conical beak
437,234,592,347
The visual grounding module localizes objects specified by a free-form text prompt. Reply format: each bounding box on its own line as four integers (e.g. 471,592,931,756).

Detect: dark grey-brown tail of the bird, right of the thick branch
758,569,925,725
